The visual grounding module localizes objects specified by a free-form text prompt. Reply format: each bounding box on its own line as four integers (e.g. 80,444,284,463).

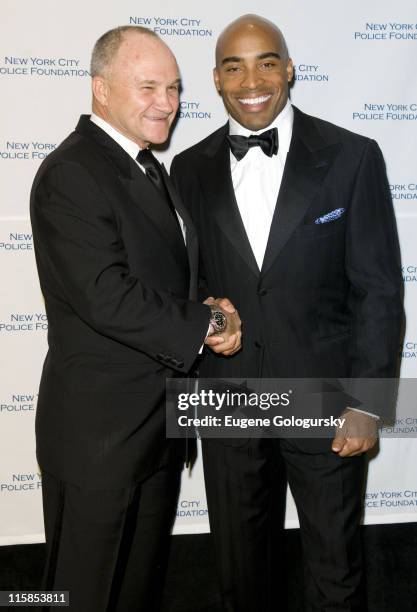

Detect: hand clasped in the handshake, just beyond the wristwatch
204,297,242,356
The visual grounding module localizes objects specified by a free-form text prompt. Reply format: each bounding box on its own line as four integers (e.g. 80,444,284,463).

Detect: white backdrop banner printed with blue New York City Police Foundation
0,0,417,544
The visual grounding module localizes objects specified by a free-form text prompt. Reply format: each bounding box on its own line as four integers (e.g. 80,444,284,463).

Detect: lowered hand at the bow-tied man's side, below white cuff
332,409,378,457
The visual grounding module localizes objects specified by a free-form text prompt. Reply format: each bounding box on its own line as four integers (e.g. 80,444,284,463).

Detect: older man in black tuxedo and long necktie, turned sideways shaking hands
31,27,240,612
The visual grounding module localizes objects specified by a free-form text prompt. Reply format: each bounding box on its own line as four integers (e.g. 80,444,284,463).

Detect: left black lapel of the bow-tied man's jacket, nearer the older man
201,124,259,276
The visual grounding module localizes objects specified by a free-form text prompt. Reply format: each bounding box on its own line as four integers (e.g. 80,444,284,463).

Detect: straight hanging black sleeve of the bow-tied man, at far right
346,140,403,414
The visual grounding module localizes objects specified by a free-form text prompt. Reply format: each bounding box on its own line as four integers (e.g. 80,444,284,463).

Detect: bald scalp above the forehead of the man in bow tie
216,14,288,66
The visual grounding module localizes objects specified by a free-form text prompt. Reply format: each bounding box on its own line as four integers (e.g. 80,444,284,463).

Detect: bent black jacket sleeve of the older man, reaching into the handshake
32,162,210,372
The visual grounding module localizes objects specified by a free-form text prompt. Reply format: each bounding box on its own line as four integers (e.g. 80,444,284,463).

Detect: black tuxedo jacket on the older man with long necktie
31,116,210,488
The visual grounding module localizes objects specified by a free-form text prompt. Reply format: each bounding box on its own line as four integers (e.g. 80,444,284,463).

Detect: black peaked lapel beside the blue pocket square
262,108,340,274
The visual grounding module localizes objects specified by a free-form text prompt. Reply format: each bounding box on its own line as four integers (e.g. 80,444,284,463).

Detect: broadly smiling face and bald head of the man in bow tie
214,16,293,131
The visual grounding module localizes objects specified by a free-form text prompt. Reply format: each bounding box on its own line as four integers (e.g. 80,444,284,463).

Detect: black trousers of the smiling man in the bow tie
203,439,366,612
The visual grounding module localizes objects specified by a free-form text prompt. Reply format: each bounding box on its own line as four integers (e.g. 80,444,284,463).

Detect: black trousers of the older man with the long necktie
42,462,181,612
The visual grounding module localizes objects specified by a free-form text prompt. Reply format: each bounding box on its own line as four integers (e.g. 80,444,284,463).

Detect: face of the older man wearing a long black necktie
93,32,180,148
